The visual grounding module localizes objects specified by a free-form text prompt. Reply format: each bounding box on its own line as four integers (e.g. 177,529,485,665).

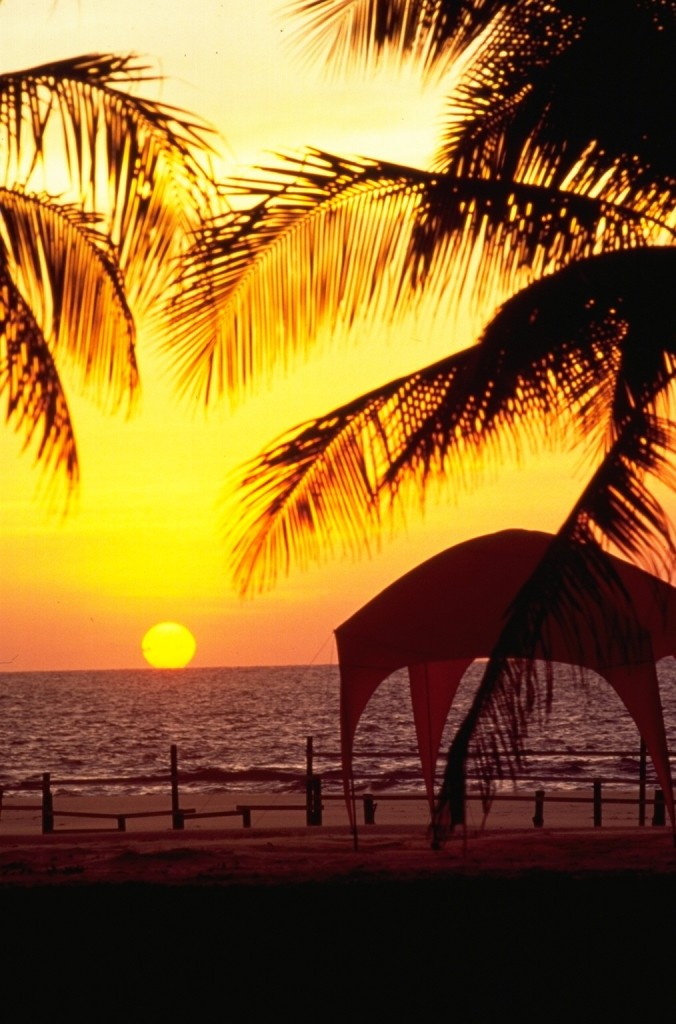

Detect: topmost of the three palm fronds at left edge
0,54,220,323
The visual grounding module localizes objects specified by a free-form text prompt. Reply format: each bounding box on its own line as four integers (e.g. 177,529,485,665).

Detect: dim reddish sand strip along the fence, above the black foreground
0,790,676,888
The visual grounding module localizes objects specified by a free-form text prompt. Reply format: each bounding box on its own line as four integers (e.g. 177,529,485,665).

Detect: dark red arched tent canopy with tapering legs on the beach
336,529,676,823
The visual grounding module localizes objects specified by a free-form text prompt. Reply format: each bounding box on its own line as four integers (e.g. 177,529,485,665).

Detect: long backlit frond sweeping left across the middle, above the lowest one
168,150,662,399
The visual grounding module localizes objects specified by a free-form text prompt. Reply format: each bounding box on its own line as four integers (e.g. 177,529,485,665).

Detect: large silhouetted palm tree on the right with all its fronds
173,0,676,825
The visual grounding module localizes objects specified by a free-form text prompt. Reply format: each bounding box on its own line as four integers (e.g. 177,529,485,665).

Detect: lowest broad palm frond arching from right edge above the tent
229,248,676,590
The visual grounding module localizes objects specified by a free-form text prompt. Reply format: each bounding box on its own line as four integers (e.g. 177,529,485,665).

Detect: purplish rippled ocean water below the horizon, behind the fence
0,658,676,795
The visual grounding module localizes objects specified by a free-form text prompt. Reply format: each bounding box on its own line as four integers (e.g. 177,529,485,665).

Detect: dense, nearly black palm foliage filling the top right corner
434,3,676,216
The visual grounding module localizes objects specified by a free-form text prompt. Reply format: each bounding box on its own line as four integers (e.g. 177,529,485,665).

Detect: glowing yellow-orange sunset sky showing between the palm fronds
0,0,580,670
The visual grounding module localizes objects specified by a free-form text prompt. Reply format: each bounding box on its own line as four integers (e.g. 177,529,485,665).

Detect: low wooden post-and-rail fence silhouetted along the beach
0,736,666,835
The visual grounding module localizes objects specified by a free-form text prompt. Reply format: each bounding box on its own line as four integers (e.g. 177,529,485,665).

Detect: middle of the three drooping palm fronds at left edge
0,189,138,408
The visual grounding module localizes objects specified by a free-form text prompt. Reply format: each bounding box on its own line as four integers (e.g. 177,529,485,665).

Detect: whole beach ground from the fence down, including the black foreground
0,794,676,1011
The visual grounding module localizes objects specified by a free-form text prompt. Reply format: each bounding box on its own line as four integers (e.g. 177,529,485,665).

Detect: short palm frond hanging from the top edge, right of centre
285,0,506,80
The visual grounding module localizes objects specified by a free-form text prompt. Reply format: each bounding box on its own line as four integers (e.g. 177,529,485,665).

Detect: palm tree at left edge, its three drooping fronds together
0,54,218,497
